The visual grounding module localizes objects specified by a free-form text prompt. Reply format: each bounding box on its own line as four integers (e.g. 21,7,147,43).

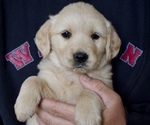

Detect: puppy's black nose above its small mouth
73,52,88,63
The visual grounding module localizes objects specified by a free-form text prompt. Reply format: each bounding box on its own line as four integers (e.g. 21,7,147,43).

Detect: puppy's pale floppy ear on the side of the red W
35,19,51,58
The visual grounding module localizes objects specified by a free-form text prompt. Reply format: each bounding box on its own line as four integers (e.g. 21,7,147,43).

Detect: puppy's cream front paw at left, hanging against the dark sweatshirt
14,77,41,122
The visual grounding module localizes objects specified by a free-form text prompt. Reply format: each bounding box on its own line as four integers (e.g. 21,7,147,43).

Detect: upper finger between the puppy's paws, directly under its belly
40,99,75,123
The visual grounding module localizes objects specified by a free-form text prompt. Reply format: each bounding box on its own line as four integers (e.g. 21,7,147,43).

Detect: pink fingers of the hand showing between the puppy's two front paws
37,99,75,125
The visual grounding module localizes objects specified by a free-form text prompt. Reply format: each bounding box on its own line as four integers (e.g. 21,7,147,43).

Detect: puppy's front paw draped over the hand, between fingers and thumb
75,91,102,125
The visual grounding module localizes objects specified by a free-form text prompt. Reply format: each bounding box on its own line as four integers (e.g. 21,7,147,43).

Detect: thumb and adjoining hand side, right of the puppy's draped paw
80,75,126,125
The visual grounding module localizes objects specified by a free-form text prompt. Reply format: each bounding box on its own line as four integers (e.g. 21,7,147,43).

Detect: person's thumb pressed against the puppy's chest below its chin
80,75,119,107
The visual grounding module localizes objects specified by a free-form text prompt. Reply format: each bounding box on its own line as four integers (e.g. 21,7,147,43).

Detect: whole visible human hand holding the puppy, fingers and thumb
37,75,126,125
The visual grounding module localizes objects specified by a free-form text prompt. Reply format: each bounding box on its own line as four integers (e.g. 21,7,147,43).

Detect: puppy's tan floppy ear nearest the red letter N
106,25,121,60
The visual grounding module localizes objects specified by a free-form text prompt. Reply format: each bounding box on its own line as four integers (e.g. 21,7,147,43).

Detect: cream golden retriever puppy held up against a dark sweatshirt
15,2,120,125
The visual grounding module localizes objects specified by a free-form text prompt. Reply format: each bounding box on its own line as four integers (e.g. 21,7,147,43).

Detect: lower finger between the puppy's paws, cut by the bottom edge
37,109,74,125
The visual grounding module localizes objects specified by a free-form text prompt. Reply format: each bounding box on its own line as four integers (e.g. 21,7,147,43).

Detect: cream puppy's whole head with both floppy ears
36,2,120,73
